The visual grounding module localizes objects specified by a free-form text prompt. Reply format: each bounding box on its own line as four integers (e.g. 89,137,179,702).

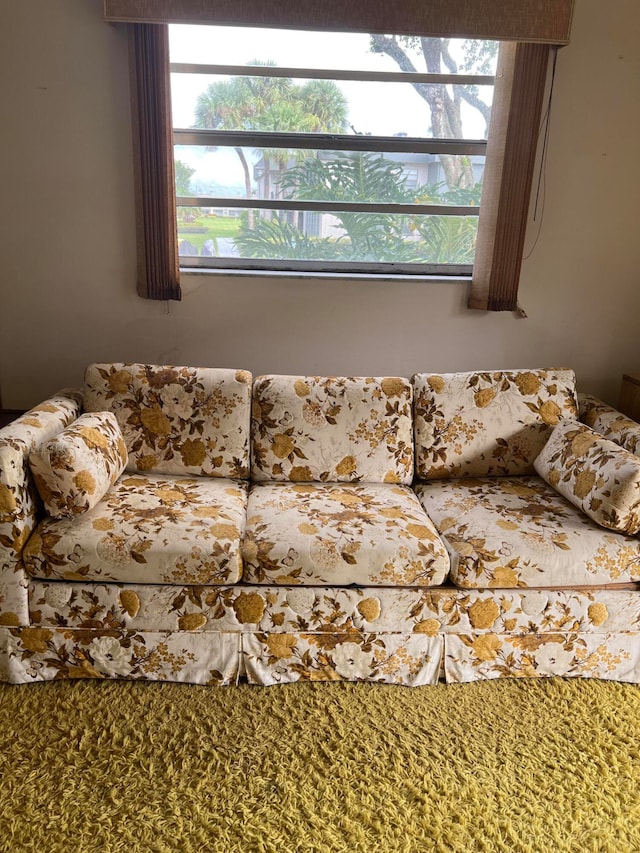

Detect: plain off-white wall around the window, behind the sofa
0,0,640,408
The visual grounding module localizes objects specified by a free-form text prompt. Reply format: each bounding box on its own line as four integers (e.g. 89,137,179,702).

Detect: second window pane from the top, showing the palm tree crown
171,72,493,139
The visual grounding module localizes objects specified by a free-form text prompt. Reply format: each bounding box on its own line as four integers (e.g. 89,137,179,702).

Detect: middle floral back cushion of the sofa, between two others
251,376,413,483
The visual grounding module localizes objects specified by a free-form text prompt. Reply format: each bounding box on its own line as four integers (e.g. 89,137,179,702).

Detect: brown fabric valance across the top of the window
104,0,573,45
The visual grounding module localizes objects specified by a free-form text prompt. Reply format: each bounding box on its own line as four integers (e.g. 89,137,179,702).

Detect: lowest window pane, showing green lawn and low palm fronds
178,207,477,267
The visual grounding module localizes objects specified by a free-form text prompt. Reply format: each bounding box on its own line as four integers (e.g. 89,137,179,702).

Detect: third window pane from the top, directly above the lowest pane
175,145,485,206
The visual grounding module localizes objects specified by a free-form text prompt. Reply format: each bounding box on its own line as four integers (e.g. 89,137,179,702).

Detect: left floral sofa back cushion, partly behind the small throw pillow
85,362,251,479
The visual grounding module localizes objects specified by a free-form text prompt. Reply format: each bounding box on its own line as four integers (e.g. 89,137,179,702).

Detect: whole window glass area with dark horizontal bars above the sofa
169,25,499,275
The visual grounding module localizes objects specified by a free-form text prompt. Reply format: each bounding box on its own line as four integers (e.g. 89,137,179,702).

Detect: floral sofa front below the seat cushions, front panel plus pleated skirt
0,580,640,686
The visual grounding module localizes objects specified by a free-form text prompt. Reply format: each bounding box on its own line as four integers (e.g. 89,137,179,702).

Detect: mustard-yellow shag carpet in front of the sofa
0,679,640,853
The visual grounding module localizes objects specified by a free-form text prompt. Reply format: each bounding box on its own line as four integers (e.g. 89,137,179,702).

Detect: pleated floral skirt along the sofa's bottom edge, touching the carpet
0,628,640,687
